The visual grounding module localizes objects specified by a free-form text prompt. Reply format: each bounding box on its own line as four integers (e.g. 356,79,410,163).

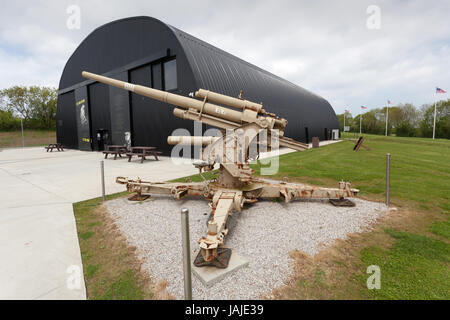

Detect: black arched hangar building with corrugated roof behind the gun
56,17,339,154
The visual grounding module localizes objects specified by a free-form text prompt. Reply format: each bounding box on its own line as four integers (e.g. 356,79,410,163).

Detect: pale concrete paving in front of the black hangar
0,141,342,299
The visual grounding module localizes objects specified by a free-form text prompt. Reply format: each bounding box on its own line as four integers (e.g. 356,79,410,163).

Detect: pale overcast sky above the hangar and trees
0,0,450,114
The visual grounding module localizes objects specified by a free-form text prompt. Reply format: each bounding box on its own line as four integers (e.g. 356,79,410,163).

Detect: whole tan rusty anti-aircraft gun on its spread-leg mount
82,72,359,268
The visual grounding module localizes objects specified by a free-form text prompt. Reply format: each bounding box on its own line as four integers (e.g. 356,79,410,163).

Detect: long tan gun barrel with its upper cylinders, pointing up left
82,71,308,150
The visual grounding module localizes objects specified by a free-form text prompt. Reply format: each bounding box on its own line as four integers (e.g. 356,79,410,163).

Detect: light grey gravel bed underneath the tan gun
105,197,387,300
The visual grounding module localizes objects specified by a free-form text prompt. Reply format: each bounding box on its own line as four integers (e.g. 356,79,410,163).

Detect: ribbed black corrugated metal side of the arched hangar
169,25,339,139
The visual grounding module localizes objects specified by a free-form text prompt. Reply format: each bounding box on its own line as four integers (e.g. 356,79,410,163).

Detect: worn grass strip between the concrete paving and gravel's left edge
73,193,158,300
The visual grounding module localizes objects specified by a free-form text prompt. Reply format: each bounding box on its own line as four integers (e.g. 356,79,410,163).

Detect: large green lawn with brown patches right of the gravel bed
179,135,450,299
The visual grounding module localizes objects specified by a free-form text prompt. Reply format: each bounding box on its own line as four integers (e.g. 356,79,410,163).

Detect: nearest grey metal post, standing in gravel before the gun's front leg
181,208,192,300
